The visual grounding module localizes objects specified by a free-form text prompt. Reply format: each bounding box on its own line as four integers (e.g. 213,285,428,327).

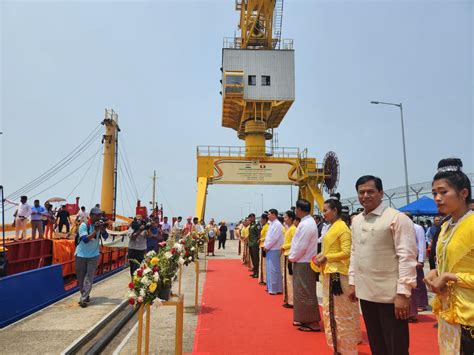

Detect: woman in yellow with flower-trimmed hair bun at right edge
425,159,474,355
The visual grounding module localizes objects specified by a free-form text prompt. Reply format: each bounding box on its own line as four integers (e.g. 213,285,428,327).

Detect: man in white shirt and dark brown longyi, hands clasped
288,199,321,332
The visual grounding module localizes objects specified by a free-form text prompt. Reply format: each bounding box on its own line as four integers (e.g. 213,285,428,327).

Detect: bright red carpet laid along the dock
193,259,438,355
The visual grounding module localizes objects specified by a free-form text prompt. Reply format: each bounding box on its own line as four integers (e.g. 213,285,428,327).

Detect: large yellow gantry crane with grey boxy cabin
196,0,332,220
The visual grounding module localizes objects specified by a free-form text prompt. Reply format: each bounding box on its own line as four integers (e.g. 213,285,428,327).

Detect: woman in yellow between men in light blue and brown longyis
280,210,296,308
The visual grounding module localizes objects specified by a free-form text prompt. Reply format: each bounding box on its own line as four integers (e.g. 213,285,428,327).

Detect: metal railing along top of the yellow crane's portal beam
196,145,301,158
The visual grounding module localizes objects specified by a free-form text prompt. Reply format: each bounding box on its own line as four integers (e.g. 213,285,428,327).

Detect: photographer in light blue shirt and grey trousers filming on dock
75,207,109,308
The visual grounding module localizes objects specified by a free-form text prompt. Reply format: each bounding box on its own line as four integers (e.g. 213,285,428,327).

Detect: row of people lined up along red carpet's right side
235,159,474,355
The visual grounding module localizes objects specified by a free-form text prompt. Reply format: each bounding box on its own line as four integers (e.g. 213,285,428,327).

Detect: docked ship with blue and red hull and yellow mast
0,110,159,328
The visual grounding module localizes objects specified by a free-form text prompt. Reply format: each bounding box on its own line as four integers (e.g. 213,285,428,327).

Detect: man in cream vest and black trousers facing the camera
349,175,417,355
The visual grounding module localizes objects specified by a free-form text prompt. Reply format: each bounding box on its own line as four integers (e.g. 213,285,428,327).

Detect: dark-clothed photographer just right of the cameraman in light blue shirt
128,216,151,278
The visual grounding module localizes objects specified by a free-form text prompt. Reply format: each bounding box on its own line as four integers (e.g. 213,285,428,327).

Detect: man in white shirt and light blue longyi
263,208,284,295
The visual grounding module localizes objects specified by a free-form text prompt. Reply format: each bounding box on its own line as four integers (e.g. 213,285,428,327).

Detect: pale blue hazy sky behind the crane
0,0,474,220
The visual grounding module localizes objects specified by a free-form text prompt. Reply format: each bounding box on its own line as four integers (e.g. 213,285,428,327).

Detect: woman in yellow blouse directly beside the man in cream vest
313,194,361,355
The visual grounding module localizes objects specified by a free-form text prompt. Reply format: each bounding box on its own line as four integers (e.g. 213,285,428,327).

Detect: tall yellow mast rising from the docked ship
100,109,120,219
